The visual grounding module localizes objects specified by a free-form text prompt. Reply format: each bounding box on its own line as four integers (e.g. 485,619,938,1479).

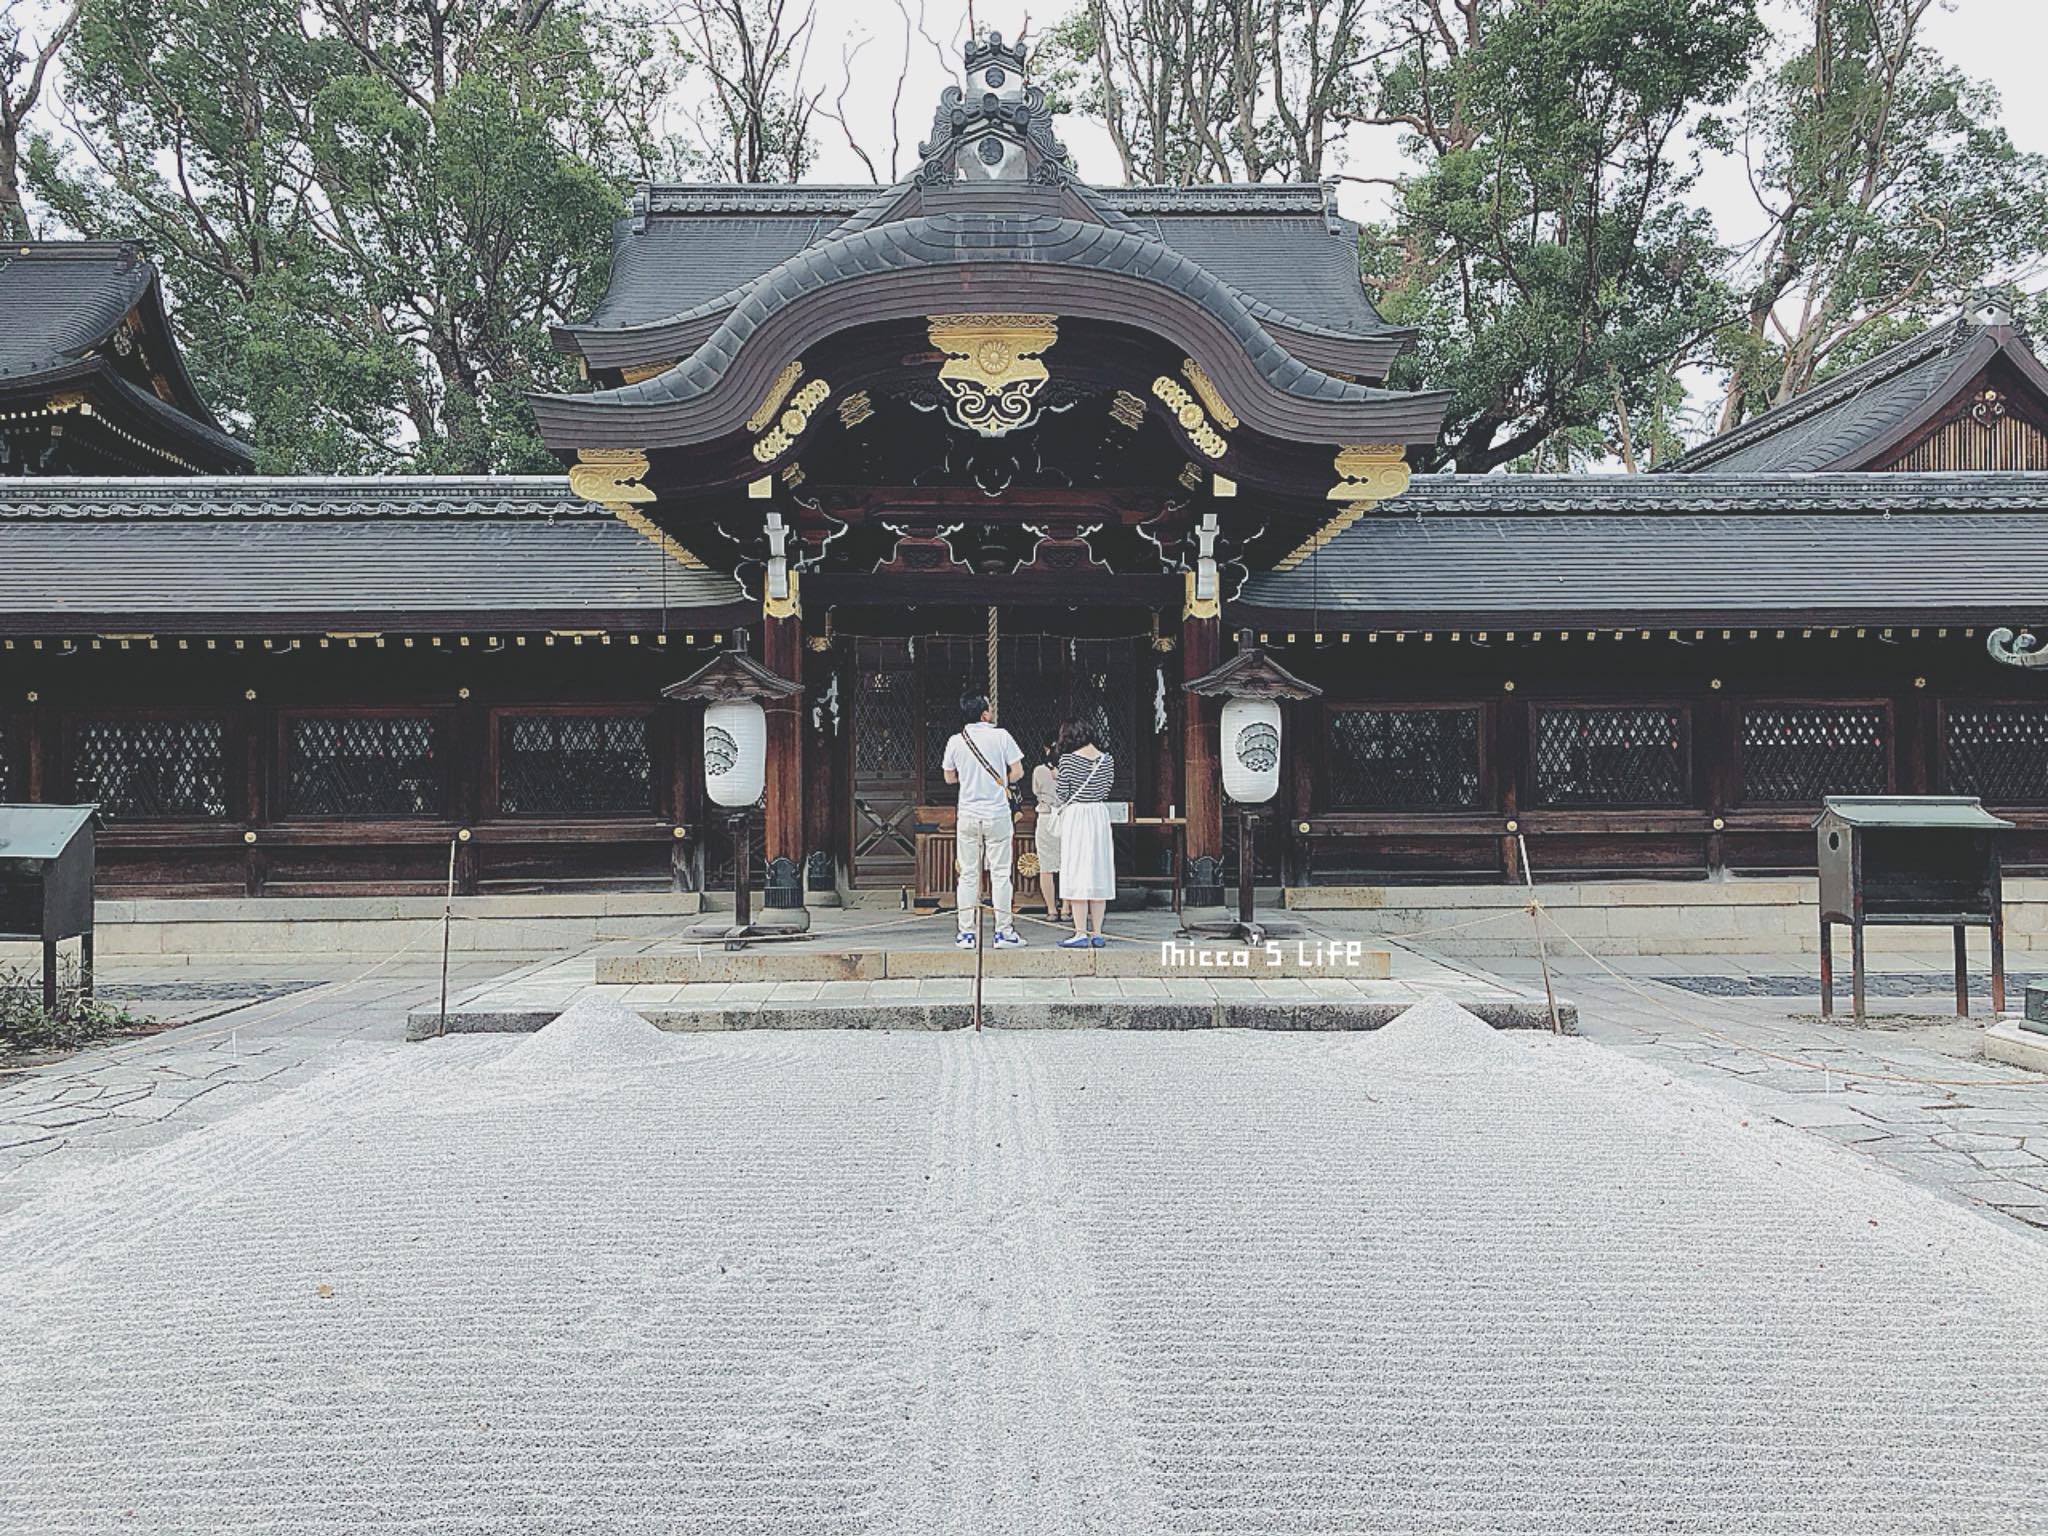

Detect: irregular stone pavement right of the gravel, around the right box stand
1466,954,2048,1233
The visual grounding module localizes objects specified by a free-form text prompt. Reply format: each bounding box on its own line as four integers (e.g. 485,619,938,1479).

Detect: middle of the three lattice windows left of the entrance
285,715,446,821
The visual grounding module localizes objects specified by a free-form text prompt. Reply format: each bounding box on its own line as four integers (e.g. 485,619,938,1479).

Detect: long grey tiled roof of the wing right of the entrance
1239,473,2048,629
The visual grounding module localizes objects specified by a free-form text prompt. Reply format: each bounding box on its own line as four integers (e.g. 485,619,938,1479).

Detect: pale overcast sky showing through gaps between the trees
809,0,2048,287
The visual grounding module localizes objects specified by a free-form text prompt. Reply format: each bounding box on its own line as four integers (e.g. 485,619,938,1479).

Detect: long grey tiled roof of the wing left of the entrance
0,477,739,631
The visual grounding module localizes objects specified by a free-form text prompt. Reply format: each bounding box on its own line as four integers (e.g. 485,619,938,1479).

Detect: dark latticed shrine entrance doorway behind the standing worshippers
848,608,1161,889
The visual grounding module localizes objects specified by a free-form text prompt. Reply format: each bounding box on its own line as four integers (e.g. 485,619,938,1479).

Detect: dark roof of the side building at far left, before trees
0,240,254,473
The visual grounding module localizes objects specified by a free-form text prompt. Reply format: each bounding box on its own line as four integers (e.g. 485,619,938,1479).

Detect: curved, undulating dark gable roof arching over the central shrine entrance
535,204,1448,449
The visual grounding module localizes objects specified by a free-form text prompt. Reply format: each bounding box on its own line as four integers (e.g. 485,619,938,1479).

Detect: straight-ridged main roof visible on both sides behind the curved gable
586,184,1389,336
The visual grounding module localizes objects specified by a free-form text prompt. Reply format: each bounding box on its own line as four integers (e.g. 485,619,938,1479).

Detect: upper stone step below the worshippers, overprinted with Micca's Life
596,938,1393,985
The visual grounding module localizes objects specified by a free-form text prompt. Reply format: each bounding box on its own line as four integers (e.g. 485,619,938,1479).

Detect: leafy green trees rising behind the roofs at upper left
31,0,666,473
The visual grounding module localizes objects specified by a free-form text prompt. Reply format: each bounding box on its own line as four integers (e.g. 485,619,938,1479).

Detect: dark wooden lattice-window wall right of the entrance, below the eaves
1272,629,2048,883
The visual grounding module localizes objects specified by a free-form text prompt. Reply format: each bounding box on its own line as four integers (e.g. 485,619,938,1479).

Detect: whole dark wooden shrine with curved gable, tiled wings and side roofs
0,39,2048,905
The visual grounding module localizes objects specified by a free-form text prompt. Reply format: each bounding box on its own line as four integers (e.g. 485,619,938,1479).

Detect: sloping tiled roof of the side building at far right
1663,315,2038,475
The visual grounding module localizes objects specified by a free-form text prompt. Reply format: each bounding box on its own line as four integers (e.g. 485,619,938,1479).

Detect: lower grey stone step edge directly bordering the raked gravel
406,997,1579,1040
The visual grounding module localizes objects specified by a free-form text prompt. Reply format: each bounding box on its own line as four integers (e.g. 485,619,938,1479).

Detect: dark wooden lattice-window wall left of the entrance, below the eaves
0,635,711,897
